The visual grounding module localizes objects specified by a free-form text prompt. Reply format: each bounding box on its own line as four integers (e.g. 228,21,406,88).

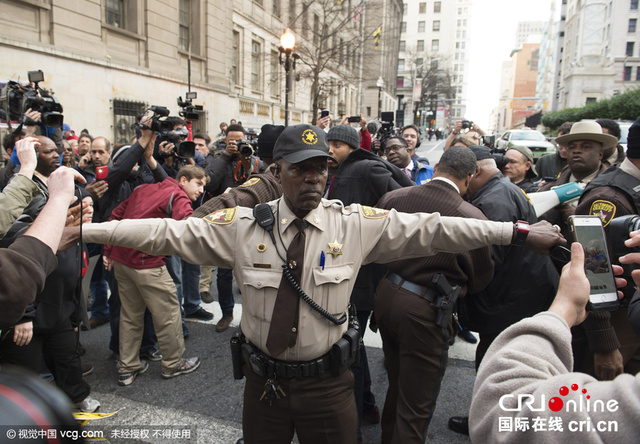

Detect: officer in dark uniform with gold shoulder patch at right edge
562,118,640,380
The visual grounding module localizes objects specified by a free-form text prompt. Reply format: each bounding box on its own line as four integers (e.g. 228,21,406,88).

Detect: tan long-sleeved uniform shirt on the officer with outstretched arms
83,199,513,361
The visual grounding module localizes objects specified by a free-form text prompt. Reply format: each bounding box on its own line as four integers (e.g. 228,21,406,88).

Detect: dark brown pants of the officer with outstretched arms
242,365,358,444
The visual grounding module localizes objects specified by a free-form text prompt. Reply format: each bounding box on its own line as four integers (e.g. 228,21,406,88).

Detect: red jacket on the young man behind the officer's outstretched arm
104,177,193,269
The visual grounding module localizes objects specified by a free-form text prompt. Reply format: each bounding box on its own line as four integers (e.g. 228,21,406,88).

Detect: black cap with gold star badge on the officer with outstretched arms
273,124,335,163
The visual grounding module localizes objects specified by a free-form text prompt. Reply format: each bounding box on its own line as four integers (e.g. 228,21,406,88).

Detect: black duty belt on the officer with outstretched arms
242,342,331,378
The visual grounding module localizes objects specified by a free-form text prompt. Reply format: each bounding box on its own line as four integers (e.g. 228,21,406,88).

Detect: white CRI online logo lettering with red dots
499,384,619,412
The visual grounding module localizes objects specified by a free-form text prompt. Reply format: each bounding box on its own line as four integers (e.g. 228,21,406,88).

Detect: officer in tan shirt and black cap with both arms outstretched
67,125,564,444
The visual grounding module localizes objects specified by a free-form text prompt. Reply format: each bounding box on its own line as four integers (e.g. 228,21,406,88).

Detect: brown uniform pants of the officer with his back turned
374,278,452,444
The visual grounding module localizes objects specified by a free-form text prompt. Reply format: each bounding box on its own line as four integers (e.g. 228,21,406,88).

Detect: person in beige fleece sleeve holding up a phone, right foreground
470,243,640,443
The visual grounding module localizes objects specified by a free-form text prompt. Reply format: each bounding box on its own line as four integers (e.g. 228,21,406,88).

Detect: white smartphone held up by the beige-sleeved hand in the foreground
569,216,619,311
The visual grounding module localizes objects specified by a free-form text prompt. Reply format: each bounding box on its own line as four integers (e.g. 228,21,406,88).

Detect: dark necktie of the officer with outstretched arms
267,219,309,357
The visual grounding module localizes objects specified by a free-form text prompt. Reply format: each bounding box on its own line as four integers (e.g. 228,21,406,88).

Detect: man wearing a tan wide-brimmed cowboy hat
540,120,618,236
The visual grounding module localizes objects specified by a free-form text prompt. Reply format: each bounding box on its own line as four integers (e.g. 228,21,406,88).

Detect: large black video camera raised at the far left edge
0,70,64,128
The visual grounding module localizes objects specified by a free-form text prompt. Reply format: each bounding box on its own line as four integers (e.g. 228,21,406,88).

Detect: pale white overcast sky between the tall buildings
466,0,561,129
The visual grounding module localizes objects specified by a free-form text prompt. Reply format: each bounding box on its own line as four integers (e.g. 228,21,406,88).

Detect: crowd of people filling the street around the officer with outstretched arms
0,104,640,444
